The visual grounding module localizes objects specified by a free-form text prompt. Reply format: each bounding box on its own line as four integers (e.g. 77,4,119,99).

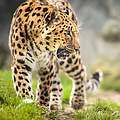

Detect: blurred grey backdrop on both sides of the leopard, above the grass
0,0,120,68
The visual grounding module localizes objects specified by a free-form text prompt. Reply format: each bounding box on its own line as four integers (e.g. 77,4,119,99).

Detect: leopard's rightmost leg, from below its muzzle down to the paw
58,52,86,110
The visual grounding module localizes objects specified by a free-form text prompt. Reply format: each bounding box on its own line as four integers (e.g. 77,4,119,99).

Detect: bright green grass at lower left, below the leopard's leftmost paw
0,71,56,120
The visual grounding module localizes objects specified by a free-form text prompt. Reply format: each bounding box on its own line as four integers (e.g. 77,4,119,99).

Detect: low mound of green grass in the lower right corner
75,101,120,120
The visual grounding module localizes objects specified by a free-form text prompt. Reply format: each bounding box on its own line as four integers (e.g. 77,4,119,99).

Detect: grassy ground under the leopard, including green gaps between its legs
0,70,120,120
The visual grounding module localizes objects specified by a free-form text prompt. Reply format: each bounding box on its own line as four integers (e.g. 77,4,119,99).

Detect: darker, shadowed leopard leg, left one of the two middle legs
36,56,55,108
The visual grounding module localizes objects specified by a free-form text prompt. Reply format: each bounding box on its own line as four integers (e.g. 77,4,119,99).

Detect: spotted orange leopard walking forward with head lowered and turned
9,0,102,110
